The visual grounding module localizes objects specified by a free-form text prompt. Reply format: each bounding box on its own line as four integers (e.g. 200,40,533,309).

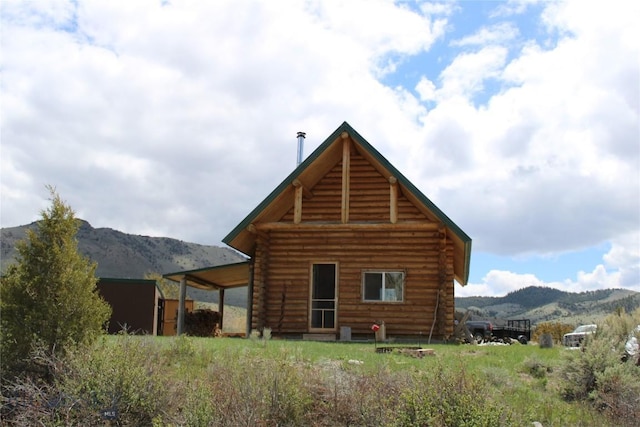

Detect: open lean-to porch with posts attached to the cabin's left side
162,260,251,336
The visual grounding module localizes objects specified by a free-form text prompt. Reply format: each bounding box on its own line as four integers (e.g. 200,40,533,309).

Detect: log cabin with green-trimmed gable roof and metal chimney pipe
165,122,471,339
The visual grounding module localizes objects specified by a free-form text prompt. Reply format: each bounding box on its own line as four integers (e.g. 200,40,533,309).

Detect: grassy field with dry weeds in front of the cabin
3,336,632,426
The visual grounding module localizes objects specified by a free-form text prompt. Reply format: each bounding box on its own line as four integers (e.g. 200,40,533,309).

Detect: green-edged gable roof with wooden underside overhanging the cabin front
222,122,471,286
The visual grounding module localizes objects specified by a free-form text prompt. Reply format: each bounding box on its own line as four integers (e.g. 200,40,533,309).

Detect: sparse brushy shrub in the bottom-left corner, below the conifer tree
3,336,170,425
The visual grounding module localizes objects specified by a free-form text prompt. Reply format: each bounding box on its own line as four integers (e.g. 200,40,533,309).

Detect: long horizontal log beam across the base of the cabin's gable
255,222,439,231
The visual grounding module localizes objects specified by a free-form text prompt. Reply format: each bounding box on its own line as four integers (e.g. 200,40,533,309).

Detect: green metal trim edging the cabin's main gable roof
222,122,471,284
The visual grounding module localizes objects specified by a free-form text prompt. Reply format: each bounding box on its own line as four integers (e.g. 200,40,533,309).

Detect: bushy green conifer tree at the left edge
0,186,111,378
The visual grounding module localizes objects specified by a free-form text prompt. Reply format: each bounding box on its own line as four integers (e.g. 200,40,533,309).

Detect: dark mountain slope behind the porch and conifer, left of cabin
0,220,246,306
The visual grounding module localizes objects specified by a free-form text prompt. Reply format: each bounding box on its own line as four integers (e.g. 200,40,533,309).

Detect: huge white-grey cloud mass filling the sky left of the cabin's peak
2,1,441,244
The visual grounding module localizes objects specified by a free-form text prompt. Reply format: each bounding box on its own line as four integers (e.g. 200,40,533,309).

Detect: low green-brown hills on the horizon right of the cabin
455,286,640,324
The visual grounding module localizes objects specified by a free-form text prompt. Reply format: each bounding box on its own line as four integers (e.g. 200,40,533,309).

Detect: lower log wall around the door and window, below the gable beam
253,229,453,338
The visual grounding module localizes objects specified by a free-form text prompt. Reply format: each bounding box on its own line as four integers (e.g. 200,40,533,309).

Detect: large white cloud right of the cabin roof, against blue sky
410,2,640,254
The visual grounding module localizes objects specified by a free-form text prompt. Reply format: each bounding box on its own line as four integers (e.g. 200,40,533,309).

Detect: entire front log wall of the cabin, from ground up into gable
251,140,454,339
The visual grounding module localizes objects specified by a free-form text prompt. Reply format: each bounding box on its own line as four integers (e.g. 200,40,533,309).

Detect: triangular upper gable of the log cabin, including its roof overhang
223,122,471,285
